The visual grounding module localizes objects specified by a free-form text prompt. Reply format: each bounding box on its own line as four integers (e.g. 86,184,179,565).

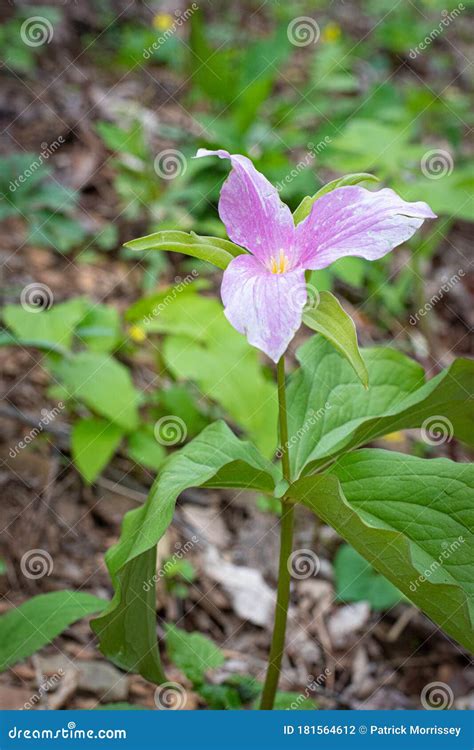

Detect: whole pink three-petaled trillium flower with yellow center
196,148,436,362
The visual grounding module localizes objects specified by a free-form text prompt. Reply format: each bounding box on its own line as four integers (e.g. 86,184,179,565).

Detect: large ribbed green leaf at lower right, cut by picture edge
287,449,474,648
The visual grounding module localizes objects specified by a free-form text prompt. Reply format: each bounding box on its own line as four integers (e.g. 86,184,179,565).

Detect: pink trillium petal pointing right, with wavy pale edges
296,186,436,269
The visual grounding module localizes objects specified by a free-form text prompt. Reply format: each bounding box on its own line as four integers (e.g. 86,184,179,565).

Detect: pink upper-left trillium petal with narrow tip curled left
196,148,295,262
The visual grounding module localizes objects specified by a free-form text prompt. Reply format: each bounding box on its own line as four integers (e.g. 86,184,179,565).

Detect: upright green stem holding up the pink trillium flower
260,356,294,710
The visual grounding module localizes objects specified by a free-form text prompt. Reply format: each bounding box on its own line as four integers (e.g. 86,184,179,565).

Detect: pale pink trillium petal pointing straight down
221,255,306,362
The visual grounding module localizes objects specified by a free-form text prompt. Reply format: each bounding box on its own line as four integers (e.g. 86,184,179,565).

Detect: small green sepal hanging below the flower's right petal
303,292,369,388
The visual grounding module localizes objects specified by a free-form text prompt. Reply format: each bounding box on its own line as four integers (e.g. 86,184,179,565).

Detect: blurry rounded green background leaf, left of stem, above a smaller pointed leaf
53,352,138,431
